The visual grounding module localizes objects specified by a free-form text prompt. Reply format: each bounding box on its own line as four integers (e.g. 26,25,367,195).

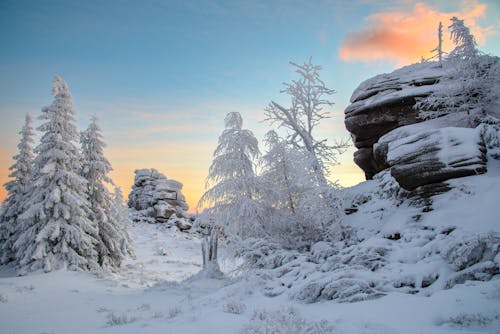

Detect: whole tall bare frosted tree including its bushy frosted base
265,59,348,243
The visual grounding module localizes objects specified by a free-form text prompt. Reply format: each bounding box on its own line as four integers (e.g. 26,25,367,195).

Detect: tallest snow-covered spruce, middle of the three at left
14,76,98,274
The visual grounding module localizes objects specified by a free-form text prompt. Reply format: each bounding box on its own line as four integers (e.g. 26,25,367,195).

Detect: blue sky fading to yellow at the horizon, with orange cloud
0,0,500,211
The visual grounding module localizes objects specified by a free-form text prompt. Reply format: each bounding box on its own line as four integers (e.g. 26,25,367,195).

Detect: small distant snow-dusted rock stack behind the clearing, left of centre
128,169,188,223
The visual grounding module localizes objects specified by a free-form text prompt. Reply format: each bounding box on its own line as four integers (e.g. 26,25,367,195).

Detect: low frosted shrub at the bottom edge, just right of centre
241,307,333,334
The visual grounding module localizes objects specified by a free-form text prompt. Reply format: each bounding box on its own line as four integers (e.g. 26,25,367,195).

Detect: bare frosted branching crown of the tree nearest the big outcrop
265,59,347,186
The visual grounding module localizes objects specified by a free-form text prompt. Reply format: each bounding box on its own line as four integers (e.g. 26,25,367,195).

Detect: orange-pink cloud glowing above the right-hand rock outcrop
339,0,492,65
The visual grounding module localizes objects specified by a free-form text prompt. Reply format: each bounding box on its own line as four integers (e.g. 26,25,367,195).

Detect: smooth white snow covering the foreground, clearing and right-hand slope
0,168,500,334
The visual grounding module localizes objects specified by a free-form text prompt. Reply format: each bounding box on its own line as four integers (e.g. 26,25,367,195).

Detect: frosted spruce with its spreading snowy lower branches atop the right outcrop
415,17,500,127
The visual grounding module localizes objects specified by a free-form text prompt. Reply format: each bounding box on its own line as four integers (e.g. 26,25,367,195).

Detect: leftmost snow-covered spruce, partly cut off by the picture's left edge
0,114,34,264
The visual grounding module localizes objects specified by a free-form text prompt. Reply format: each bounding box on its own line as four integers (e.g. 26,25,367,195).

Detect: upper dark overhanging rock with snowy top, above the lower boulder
344,63,444,179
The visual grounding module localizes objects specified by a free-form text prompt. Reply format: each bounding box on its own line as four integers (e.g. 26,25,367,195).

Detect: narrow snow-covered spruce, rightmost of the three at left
80,116,131,270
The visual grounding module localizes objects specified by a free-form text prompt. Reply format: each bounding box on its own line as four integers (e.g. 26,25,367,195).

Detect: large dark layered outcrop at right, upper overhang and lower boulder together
345,63,486,190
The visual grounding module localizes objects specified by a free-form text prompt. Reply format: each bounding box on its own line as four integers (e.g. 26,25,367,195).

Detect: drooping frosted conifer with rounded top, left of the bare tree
198,112,263,238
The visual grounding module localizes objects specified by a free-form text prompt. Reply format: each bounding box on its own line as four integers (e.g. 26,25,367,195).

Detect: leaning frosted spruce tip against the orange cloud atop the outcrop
448,16,478,60
